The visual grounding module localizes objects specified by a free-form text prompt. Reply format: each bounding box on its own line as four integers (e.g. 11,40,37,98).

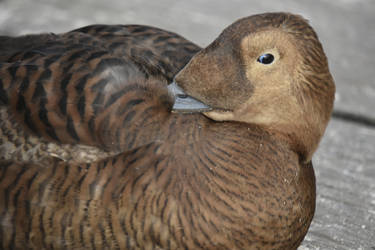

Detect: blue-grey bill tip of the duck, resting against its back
168,81,212,113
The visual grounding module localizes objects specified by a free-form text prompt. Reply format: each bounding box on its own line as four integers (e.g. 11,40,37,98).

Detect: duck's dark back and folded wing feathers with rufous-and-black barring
0,25,200,165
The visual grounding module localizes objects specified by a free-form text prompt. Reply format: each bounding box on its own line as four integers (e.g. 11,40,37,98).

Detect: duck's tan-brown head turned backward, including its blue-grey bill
170,13,335,162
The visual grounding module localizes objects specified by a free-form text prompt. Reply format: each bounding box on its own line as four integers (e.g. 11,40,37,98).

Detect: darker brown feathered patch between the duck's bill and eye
175,51,252,109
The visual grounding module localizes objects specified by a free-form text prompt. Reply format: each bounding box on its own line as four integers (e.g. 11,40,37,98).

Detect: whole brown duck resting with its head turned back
0,12,335,249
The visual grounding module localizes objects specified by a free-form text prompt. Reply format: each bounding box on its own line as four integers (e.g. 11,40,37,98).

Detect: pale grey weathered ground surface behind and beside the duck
0,0,375,250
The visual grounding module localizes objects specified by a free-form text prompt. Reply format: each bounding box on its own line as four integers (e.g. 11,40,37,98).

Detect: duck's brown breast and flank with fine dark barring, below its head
0,114,315,249
